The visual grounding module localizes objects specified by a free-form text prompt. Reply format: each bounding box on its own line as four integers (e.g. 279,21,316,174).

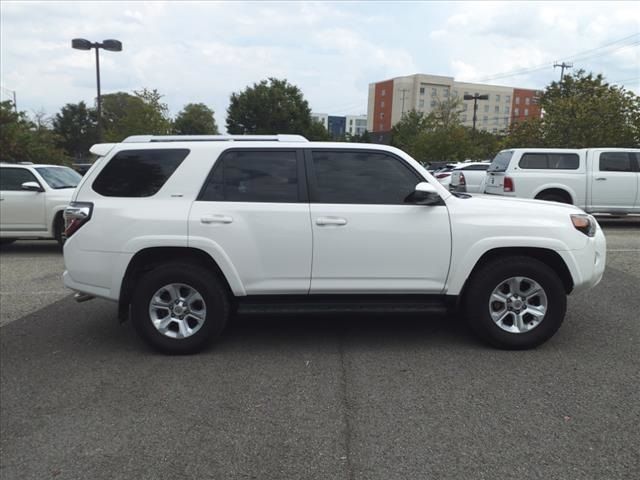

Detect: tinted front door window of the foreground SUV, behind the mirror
313,151,423,205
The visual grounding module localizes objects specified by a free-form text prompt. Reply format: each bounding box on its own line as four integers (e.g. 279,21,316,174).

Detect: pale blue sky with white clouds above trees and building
0,0,640,132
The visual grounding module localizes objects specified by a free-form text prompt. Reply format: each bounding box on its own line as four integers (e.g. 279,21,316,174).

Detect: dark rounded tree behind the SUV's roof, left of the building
227,78,319,136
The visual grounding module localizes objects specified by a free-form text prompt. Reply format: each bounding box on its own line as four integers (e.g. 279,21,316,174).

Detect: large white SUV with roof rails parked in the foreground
64,136,605,353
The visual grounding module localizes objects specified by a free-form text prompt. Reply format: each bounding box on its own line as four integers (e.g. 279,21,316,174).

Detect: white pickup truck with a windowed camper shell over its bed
485,148,640,214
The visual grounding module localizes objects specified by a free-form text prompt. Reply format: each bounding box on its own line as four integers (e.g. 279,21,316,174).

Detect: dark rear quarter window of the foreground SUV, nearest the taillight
93,148,189,197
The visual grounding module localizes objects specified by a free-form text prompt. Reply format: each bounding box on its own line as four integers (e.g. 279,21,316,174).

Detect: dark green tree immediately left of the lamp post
52,102,99,162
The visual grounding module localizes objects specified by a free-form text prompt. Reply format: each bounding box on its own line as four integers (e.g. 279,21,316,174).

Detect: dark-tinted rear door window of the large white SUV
200,150,298,203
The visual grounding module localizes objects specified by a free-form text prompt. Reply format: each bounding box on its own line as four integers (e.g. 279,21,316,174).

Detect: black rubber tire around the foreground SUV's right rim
463,256,567,350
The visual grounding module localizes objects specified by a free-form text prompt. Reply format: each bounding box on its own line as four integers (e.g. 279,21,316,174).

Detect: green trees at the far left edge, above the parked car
0,101,69,165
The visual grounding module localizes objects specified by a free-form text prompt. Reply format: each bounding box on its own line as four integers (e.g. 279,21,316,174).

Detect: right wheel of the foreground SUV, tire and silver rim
464,256,567,350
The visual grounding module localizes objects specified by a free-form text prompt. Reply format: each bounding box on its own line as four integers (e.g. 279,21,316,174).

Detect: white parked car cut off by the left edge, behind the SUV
0,163,82,244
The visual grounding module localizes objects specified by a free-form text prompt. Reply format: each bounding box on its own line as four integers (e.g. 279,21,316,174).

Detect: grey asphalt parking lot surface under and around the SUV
0,218,640,480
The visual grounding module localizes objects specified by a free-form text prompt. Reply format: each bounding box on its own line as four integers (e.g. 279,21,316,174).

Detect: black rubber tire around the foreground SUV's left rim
131,262,230,355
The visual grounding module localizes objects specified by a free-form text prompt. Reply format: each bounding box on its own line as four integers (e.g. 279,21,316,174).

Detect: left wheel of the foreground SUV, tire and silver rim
131,263,229,354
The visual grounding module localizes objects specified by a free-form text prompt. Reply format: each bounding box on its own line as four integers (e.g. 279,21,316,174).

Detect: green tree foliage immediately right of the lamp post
102,88,171,142
